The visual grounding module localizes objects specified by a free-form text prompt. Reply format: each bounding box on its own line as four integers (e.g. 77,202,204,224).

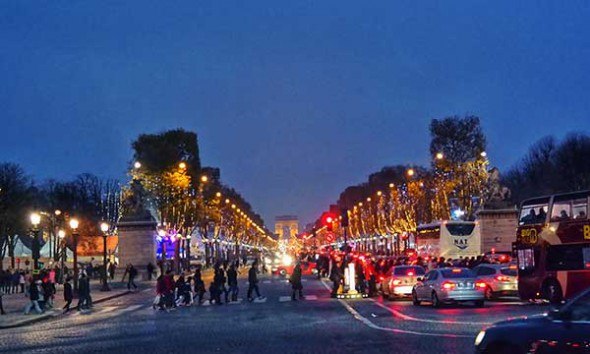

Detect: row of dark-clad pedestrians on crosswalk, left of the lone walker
153,260,264,311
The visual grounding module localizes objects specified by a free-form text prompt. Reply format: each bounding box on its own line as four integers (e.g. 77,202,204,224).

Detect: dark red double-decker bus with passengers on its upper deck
513,191,590,303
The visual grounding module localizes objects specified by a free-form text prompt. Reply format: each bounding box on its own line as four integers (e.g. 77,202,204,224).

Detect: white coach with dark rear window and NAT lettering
416,221,482,259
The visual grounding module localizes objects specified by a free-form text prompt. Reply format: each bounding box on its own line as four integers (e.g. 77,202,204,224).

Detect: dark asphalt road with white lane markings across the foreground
0,277,547,354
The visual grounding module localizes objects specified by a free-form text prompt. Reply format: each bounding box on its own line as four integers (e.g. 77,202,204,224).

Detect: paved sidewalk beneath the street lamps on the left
0,281,135,329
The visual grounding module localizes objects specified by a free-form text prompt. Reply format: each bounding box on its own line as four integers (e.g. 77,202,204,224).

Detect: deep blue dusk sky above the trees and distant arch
0,0,590,225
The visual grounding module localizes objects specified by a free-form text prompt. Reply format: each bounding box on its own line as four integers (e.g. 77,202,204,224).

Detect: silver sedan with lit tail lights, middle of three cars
412,267,486,307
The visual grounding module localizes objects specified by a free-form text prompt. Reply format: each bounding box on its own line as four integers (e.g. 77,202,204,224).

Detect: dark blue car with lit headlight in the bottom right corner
475,289,590,354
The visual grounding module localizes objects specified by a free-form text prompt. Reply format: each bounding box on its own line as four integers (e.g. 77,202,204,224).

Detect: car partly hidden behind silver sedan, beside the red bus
473,264,518,300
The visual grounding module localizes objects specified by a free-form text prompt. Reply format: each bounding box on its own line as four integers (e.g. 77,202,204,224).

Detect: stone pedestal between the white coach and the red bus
477,209,518,253
